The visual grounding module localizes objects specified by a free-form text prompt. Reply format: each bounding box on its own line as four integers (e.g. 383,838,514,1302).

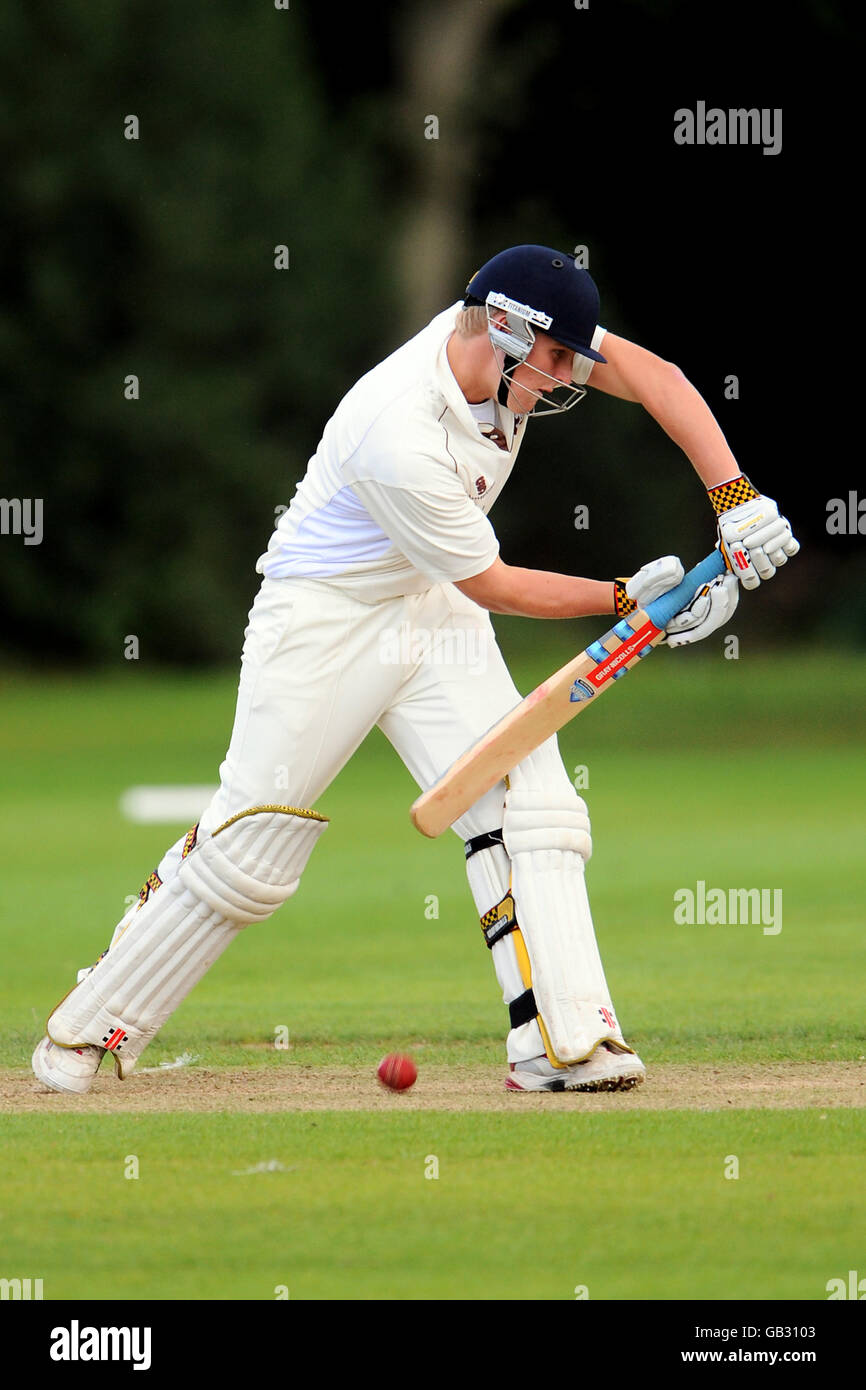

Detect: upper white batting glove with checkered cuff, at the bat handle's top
709,474,799,589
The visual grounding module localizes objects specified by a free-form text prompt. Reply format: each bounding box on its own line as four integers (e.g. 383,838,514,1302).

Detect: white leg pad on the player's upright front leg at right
502,778,631,1065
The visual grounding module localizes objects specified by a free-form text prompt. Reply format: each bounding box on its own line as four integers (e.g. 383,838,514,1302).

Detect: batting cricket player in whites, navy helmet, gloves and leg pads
33,246,798,1094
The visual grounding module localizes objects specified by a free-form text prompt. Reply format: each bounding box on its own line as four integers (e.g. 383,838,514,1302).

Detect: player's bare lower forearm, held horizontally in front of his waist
457,560,614,619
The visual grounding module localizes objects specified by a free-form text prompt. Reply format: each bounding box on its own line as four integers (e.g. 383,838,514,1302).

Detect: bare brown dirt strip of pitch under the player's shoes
0,1062,866,1115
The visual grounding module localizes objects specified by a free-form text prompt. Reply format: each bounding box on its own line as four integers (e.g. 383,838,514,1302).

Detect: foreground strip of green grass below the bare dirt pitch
3,1111,866,1301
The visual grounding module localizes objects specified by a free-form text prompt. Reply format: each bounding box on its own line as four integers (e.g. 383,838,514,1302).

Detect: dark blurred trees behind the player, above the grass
0,0,866,664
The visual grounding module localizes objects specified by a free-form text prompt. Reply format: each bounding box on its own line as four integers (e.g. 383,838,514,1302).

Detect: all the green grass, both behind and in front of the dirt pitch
0,642,866,1300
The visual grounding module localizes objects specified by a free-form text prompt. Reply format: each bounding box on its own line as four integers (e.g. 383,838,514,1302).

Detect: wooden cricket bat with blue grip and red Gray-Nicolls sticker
410,550,726,840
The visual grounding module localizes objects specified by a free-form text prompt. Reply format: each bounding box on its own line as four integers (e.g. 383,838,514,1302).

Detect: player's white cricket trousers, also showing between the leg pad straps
136,578,583,1061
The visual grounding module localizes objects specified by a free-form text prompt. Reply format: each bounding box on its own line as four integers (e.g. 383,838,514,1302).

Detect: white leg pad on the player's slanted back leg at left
47,806,328,1079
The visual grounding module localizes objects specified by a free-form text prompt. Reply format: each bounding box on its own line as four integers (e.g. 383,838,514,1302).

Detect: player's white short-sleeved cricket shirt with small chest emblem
256,302,603,603
